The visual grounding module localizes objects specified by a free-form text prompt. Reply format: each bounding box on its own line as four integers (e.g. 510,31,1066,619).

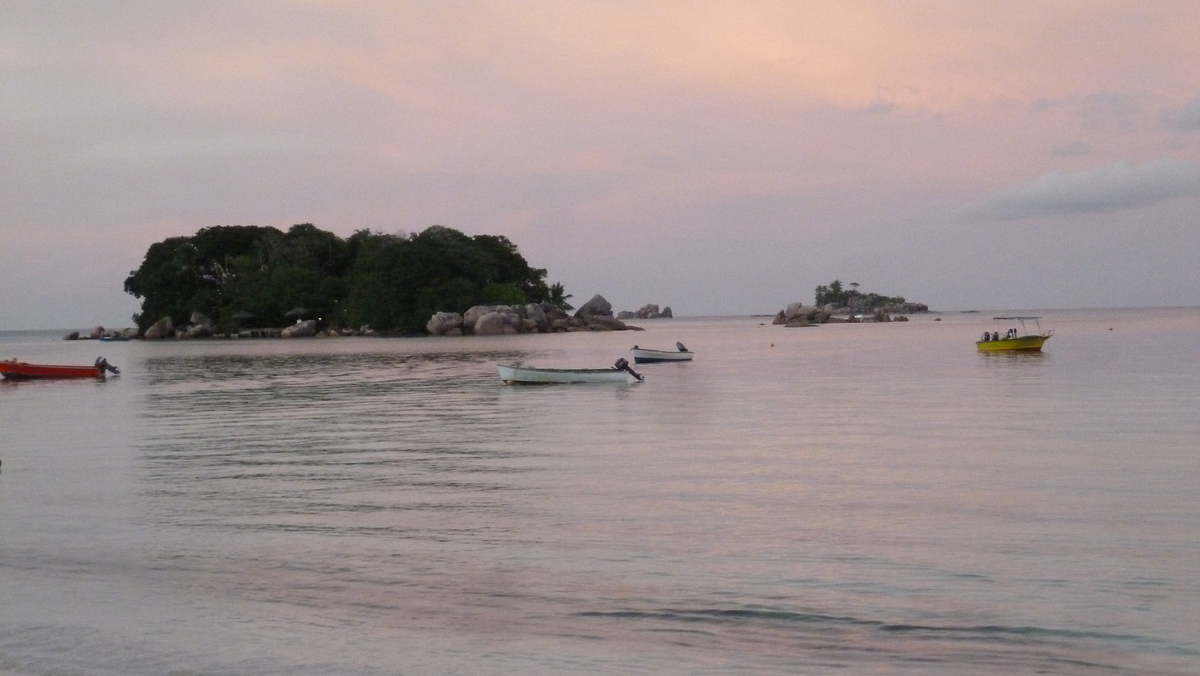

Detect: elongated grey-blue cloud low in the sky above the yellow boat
959,157,1200,222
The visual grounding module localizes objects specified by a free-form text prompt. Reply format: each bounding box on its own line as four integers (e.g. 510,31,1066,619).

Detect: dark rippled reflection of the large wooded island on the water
137,353,540,534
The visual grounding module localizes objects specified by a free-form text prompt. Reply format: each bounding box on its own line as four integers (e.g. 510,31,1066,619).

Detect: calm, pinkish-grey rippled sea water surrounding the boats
0,309,1200,676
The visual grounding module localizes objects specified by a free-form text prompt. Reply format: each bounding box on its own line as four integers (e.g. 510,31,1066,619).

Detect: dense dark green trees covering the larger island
125,223,554,331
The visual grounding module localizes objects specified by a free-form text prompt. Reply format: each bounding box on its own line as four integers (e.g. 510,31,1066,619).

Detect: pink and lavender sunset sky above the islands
0,0,1200,330
